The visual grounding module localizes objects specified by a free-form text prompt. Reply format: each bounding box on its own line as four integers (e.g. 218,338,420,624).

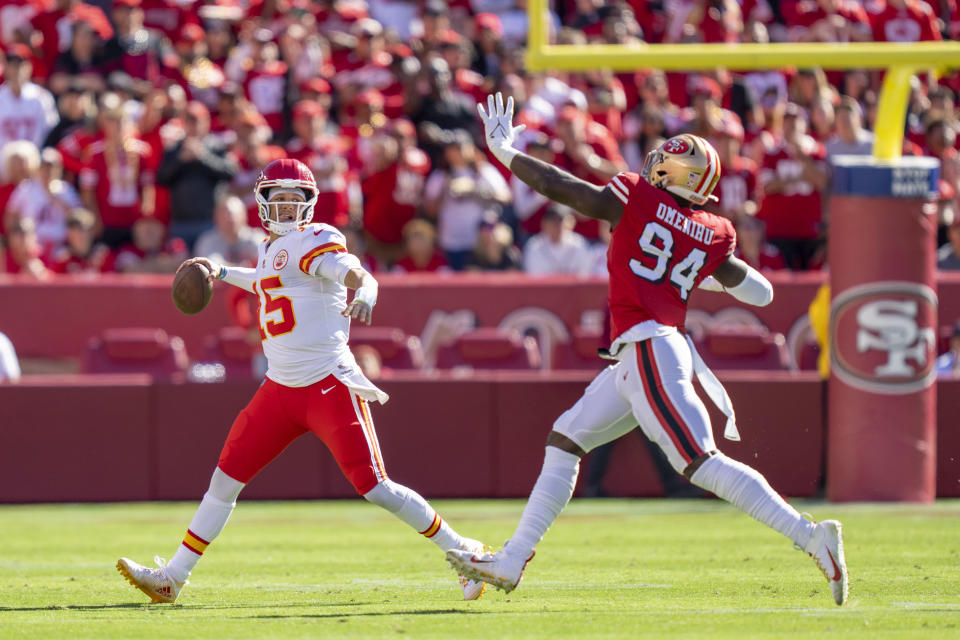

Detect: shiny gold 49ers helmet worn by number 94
640,133,720,204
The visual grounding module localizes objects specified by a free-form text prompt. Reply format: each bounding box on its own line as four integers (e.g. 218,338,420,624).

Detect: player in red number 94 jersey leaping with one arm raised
447,93,847,604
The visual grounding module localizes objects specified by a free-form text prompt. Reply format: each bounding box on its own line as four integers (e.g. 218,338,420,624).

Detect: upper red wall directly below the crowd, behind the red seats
0,273,960,370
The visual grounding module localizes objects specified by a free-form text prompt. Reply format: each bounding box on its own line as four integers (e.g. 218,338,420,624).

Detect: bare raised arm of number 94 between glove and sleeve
510,153,623,224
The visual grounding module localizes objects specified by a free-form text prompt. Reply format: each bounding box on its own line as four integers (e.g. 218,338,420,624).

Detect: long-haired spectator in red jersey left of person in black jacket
80,93,156,247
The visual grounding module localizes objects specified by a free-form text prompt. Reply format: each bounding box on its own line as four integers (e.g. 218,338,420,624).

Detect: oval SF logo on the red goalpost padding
830,282,937,394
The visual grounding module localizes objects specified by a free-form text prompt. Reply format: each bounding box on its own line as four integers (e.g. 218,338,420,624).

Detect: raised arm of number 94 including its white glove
477,93,623,225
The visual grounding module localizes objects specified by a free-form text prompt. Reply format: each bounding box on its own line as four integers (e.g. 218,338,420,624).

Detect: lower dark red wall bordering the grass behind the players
0,373,960,502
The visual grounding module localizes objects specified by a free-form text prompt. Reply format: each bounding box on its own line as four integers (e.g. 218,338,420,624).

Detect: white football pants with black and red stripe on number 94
553,333,716,473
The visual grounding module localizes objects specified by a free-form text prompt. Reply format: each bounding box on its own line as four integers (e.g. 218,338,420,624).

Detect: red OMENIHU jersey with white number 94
607,173,737,338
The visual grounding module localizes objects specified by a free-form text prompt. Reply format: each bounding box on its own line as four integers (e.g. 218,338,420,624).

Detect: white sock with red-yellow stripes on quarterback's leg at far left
167,467,244,582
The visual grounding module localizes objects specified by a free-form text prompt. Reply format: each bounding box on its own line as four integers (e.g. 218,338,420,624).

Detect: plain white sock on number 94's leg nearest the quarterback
508,446,580,559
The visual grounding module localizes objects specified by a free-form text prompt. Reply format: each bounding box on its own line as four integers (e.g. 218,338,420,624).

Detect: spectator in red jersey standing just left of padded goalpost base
757,103,827,270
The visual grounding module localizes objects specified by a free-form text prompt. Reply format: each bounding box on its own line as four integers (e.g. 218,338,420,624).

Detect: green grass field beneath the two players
0,500,960,640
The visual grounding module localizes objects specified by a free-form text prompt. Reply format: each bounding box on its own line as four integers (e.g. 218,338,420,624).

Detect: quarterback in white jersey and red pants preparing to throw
117,159,485,602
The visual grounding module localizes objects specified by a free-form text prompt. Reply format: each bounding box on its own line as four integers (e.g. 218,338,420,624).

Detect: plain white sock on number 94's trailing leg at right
690,453,816,549
